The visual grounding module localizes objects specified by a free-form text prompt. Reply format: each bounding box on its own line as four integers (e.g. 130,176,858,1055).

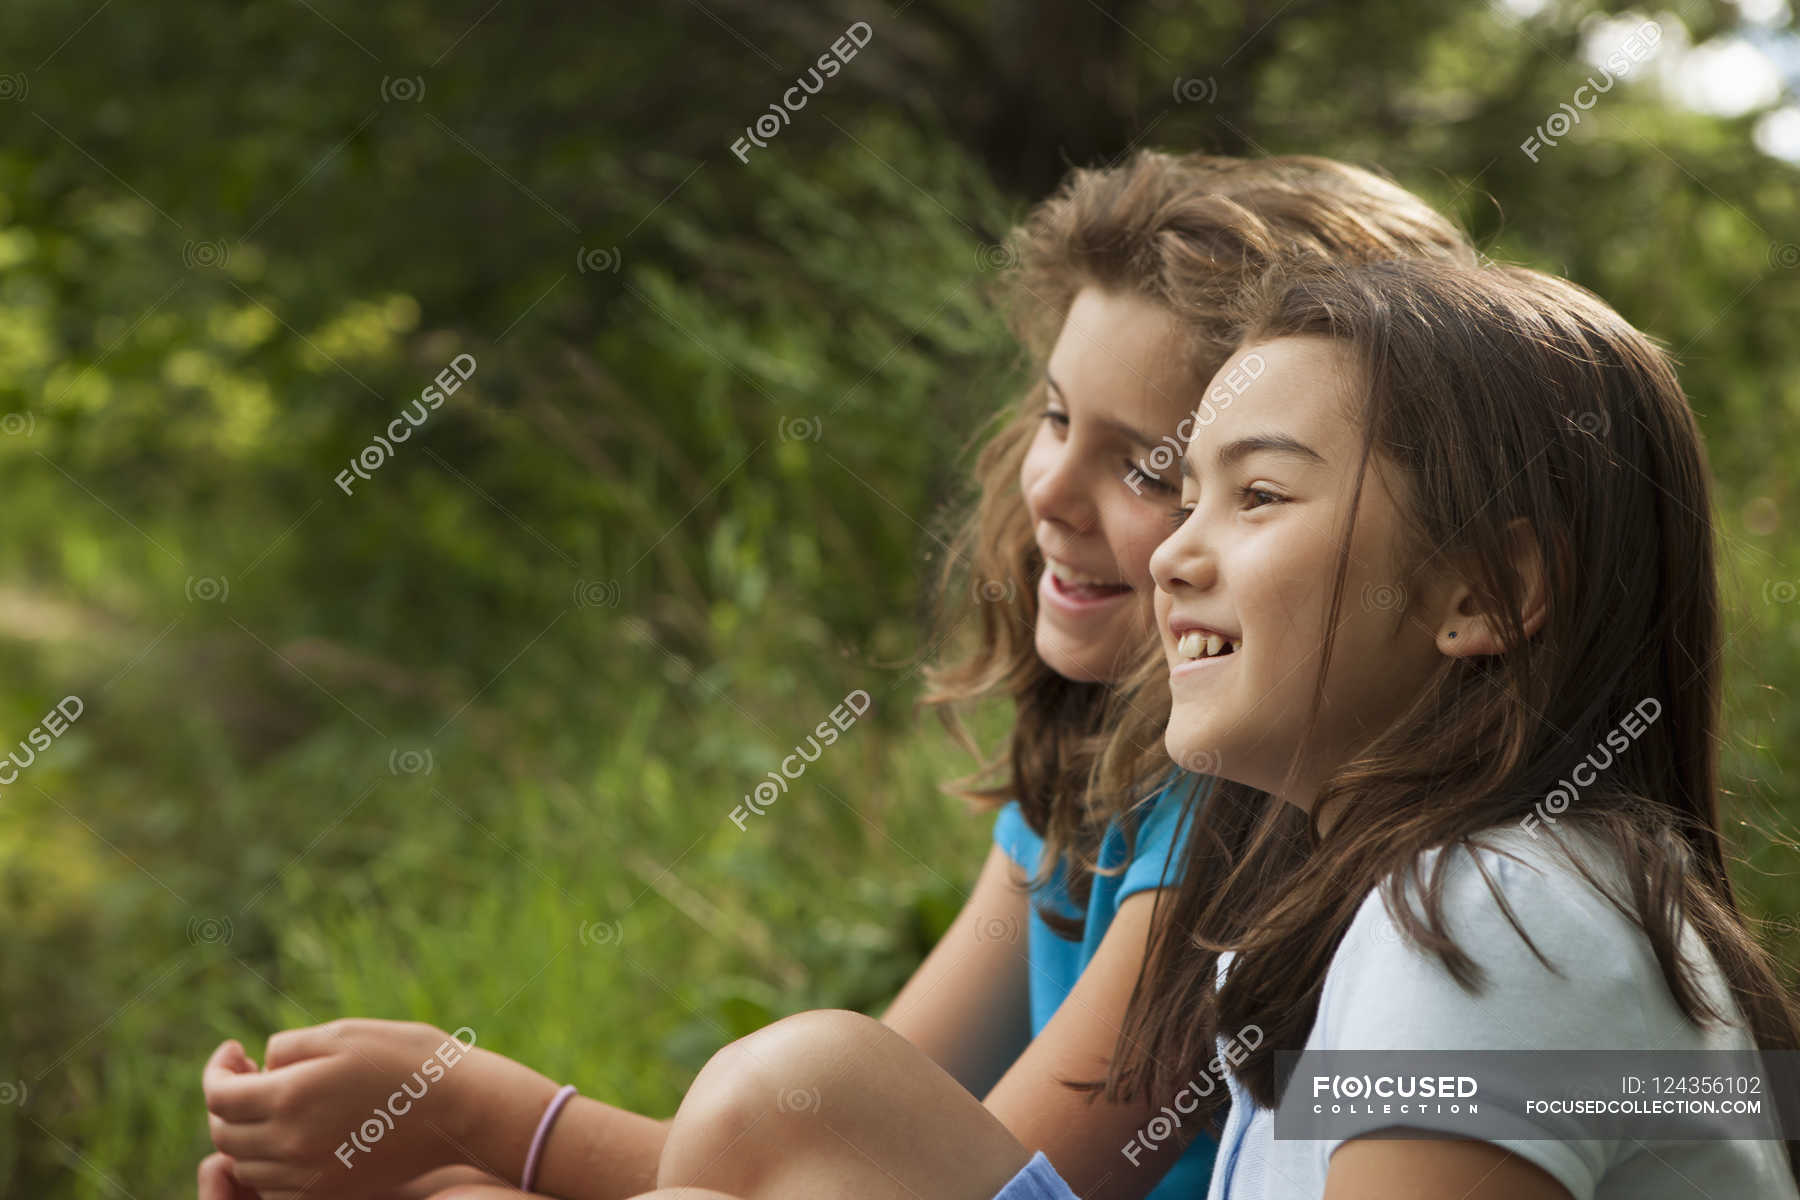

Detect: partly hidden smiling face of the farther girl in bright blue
1019,286,1193,682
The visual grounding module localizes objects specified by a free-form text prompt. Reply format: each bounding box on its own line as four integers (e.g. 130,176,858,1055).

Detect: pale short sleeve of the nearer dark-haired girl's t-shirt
1318,834,1661,1200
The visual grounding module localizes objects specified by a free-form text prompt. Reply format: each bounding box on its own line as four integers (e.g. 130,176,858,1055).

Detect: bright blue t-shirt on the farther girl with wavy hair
994,781,1219,1200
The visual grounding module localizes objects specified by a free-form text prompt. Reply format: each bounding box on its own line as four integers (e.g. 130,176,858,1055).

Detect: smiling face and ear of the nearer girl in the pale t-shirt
1150,338,1454,810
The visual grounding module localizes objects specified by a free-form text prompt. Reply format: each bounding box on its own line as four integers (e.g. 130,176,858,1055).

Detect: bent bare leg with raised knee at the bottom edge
657,1011,1031,1200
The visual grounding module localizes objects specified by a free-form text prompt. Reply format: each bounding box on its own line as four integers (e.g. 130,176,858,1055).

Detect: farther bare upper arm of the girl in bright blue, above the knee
882,846,1031,1096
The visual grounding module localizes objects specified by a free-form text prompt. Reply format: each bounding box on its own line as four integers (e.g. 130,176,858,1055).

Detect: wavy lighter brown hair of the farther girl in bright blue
922,149,1474,937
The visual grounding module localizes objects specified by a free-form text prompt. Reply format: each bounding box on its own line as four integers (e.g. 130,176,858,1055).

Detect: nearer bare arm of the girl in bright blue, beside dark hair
985,891,1186,1200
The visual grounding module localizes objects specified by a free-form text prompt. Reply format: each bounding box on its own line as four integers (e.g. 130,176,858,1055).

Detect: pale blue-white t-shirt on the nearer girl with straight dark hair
1208,826,1796,1200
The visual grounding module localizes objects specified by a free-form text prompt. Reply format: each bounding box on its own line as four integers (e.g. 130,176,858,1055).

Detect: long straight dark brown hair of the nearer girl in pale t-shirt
1107,261,1800,1175
